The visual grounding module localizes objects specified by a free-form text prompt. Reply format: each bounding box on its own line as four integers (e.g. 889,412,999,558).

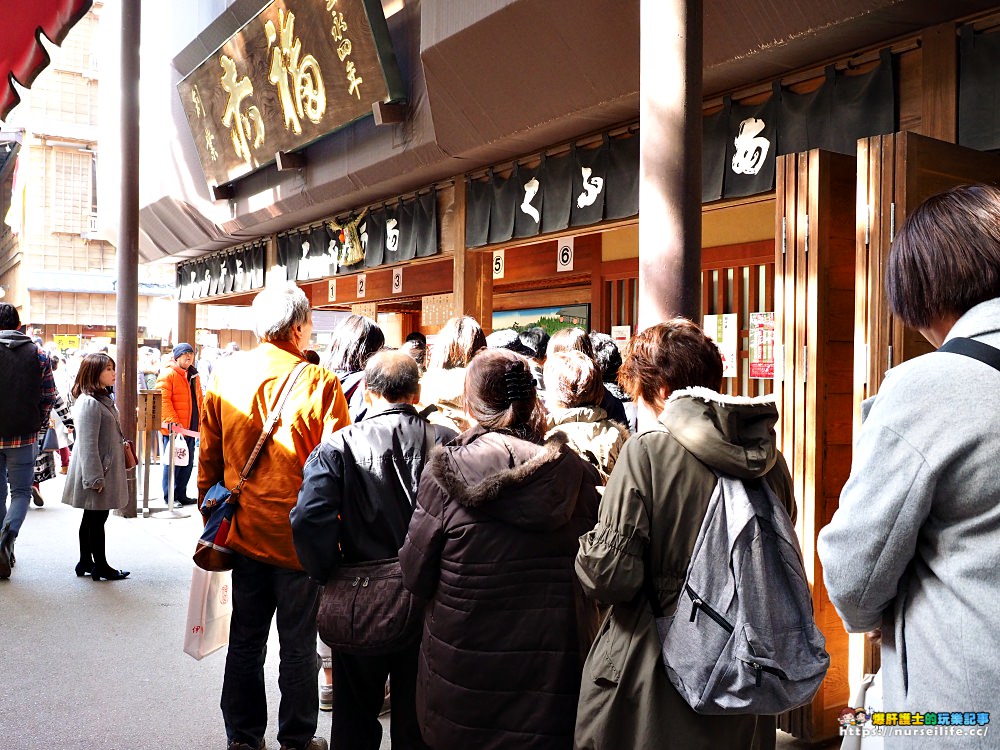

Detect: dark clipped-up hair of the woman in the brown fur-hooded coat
465,349,545,443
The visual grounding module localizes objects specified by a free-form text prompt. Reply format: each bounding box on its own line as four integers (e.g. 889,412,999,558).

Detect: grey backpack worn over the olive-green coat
647,475,830,714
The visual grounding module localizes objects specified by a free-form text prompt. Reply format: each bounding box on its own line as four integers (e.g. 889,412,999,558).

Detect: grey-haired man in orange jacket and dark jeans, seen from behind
198,282,351,750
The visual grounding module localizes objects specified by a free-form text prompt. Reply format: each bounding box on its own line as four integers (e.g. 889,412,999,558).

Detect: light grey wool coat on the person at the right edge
817,299,1000,748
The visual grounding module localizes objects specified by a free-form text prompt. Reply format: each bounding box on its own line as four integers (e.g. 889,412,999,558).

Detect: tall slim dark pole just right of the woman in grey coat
115,3,141,518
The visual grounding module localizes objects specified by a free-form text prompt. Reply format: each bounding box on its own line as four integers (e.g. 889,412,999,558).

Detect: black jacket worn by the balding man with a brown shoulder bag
290,404,434,581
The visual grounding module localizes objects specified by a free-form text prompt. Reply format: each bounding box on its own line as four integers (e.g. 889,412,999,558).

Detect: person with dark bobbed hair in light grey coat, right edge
817,185,1000,748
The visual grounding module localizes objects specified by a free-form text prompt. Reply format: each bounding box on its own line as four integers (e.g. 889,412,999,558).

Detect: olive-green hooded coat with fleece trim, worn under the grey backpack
576,388,793,750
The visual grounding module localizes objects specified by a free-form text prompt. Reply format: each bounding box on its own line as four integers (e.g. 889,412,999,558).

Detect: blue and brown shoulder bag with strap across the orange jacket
194,362,309,571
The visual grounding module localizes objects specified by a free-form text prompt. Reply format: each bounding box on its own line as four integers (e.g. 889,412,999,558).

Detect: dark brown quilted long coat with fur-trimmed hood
400,427,600,750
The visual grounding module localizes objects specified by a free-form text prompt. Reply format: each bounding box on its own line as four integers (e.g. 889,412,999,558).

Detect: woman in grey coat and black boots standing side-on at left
63,354,129,581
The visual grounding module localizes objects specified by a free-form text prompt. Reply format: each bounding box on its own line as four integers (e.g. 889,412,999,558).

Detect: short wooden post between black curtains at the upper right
920,23,958,143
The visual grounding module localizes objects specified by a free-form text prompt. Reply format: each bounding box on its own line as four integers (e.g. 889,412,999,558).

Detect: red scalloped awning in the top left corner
0,0,92,120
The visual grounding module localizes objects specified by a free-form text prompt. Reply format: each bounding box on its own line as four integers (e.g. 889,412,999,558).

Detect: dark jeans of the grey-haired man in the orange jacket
221,555,320,748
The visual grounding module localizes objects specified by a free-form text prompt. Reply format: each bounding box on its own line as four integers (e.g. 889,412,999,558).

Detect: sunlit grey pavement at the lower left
0,467,389,750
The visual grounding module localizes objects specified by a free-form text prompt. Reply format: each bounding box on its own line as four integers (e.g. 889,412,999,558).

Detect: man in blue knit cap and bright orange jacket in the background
156,343,204,505
